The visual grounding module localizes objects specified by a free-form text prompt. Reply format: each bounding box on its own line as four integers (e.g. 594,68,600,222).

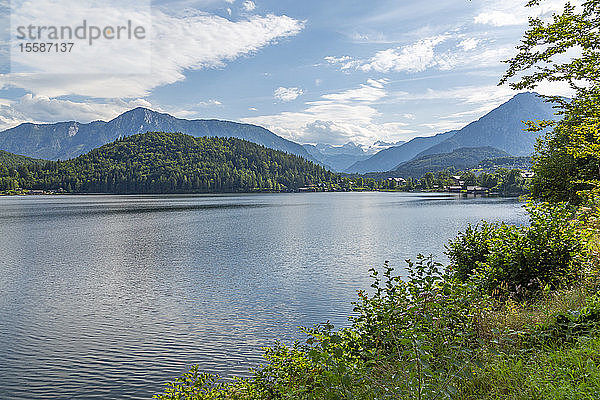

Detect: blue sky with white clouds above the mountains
0,0,570,146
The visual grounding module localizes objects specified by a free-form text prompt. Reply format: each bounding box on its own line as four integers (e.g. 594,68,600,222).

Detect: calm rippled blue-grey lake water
0,193,526,399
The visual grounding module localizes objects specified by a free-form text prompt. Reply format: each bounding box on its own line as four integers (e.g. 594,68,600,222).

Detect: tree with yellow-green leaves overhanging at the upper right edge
500,0,600,203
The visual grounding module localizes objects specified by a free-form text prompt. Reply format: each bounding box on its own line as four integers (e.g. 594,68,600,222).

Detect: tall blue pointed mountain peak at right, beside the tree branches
418,92,557,156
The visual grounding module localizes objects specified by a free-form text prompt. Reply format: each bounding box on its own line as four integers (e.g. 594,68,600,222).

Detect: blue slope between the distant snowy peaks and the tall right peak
344,131,456,174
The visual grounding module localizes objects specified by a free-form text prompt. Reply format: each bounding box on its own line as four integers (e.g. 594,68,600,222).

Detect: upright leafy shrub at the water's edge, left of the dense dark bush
352,255,486,399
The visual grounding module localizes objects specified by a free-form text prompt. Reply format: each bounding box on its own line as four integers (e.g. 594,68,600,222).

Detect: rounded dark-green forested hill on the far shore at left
0,132,335,193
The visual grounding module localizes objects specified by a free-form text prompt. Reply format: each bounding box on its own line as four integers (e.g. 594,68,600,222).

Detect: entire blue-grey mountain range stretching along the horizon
0,92,556,174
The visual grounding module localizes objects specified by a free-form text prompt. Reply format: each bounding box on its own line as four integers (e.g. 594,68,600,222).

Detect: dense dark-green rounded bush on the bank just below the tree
446,204,584,299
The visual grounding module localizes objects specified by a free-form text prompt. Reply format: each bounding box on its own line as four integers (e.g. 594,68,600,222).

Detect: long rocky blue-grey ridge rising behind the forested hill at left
0,107,314,161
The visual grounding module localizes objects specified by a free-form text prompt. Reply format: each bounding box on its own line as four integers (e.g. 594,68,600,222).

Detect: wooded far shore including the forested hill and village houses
0,132,531,196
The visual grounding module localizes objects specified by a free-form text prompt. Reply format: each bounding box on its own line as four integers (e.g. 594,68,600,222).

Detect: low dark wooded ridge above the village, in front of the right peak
393,146,510,178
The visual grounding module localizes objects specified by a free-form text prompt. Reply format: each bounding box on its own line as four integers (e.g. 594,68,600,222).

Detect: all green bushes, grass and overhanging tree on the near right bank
155,0,600,400
